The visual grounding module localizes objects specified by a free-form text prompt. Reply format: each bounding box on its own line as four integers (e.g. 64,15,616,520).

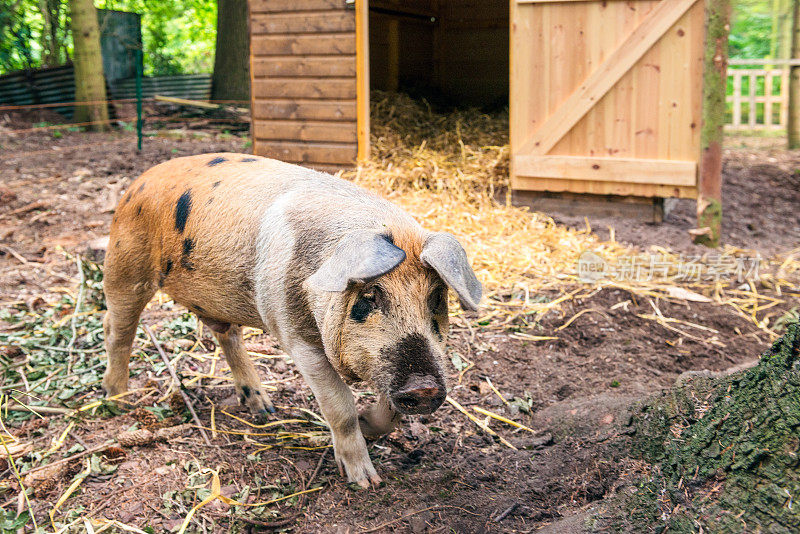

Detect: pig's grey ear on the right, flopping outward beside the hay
420,233,483,311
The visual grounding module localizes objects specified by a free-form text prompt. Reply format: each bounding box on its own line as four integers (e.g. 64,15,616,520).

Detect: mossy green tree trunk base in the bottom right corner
626,323,800,532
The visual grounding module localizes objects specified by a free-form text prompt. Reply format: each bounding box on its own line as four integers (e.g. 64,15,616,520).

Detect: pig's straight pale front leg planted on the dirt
291,346,381,488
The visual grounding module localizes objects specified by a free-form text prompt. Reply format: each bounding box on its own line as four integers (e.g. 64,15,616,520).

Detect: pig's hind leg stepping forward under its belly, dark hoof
211,324,275,415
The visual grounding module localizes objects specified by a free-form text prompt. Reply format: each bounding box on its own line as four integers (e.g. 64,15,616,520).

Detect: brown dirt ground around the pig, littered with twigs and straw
0,121,800,533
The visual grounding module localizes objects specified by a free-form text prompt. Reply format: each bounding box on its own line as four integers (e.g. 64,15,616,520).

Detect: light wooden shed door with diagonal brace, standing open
510,0,704,198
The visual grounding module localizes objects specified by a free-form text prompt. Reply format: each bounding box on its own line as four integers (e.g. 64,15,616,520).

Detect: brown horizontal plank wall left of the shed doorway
250,0,357,169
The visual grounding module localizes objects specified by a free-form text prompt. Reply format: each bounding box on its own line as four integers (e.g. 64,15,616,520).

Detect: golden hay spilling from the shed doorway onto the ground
345,91,800,338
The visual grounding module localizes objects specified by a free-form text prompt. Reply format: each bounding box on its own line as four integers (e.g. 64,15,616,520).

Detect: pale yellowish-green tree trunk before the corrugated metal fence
69,0,108,130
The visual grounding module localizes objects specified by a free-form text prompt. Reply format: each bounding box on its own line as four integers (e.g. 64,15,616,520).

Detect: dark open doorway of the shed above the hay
367,0,509,115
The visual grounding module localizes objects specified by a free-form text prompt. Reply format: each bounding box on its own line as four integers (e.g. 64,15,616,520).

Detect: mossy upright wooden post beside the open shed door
694,0,731,247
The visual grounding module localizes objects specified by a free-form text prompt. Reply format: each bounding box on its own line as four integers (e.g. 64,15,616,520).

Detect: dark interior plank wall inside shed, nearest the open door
435,0,509,106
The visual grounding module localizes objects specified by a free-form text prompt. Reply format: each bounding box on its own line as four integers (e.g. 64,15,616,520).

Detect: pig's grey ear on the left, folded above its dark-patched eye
308,231,406,292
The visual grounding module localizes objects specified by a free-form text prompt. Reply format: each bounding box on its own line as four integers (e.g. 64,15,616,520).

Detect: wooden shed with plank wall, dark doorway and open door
250,0,705,217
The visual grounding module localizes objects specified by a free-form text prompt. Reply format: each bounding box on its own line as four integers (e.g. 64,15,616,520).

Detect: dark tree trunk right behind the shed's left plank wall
211,0,250,101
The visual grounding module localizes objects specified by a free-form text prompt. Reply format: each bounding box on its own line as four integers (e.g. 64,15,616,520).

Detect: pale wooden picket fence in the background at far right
726,59,800,131
